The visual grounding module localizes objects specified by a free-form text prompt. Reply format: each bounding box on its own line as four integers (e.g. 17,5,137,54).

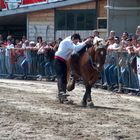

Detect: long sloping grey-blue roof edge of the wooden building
0,0,94,17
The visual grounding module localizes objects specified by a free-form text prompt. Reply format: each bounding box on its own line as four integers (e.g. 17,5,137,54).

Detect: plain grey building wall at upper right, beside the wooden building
106,0,140,35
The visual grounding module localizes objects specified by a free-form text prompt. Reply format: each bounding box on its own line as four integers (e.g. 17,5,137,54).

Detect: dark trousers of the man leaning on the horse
54,59,67,93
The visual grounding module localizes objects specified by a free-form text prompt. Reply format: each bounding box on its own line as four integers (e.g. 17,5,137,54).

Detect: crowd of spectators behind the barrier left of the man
0,35,62,81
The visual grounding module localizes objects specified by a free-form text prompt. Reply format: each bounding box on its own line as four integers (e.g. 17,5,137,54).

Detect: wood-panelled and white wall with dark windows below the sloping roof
27,0,106,41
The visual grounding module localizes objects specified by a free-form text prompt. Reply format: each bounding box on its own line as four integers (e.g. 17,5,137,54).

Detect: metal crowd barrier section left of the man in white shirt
0,48,55,79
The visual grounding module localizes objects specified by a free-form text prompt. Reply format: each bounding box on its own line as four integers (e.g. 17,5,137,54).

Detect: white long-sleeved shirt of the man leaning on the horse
55,36,86,60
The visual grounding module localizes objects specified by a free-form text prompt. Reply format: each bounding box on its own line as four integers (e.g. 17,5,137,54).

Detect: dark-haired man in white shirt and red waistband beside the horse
54,33,92,100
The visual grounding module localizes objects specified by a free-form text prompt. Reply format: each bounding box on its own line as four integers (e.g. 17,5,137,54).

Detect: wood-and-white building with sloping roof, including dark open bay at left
0,0,107,42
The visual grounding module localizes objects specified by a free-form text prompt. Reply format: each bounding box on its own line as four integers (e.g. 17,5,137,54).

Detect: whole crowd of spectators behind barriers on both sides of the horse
0,26,140,95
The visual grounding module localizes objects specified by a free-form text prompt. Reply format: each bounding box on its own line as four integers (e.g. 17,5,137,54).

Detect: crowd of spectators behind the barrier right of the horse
94,26,140,92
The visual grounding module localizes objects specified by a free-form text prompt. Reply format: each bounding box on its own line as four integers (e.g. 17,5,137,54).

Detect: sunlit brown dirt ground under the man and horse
0,79,140,140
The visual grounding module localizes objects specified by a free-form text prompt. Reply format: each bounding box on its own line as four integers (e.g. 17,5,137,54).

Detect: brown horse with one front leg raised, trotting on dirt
67,42,106,107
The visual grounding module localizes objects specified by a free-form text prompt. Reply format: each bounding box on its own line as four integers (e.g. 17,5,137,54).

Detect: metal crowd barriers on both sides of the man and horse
0,48,140,91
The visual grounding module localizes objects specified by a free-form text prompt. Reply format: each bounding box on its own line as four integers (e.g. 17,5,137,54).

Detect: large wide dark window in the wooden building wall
55,9,96,30
